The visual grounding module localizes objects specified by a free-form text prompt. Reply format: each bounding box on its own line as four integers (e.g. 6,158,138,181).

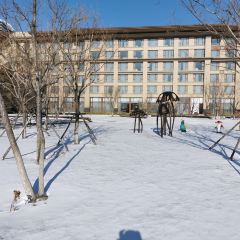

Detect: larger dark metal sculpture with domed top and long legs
156,91,179,137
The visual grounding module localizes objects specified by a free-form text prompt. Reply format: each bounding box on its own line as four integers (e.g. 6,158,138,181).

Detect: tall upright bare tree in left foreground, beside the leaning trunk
0,0,70,199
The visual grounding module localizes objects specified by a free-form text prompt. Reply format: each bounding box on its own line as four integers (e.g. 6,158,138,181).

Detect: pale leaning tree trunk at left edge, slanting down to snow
0,92,36,201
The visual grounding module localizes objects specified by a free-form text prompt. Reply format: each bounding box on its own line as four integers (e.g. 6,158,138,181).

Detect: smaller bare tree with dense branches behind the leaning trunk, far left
0,34,35,138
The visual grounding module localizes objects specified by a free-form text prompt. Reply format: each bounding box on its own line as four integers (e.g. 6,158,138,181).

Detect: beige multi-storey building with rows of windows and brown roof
46,26,240,114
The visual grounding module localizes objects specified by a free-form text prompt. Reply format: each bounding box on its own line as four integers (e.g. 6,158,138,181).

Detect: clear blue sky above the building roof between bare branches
64,0,198,27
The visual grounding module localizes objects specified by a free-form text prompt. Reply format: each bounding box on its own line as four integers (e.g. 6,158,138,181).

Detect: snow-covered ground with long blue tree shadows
0,116,240,240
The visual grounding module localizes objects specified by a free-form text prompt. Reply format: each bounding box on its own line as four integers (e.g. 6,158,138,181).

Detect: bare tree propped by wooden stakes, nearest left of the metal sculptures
61,14,111,144
